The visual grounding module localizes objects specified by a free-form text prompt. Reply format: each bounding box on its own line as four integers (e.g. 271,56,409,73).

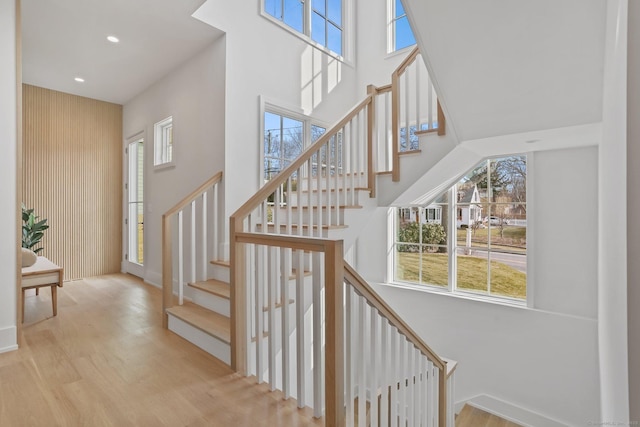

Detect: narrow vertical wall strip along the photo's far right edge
627,1,640,421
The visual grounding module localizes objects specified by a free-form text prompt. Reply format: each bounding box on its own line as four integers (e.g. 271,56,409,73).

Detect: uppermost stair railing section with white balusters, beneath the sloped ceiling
391,46,445,181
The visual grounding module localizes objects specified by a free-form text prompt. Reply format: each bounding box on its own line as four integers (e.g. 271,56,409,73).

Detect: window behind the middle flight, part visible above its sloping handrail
263,111,326,181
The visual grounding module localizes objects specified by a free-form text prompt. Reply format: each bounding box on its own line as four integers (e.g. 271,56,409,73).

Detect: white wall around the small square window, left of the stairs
123,37,227,285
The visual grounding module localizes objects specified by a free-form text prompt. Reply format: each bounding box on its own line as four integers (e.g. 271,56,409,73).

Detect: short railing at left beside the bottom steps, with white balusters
162,172,222,328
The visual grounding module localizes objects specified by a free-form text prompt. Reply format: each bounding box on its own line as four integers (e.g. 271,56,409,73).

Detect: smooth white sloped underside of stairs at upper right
403,0,606,141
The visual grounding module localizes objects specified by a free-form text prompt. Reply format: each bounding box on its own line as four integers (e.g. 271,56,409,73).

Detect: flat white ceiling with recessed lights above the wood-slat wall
22,0,222,104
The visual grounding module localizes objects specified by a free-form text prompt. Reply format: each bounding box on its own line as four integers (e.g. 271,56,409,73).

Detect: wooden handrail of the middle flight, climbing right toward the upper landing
231,94,373,220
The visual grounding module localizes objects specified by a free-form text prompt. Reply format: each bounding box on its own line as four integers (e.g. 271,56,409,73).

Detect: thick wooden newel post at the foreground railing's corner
324,240,345,427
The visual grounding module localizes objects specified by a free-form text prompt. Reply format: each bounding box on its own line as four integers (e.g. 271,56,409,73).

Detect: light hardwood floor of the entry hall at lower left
0,274,323,427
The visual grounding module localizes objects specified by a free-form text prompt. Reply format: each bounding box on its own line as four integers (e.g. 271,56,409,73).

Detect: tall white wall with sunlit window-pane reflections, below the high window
194,0,362,221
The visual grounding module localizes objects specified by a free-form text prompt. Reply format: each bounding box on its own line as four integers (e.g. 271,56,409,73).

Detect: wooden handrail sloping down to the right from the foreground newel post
344,262,447,374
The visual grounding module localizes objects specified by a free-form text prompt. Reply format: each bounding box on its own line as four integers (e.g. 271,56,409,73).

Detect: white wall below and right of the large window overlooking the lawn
357,147,600,425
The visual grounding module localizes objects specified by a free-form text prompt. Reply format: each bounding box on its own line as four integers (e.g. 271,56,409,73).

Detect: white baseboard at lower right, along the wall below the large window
455,394,567,427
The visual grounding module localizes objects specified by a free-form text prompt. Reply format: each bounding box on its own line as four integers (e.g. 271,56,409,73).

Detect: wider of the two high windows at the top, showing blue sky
263,0,344,56
